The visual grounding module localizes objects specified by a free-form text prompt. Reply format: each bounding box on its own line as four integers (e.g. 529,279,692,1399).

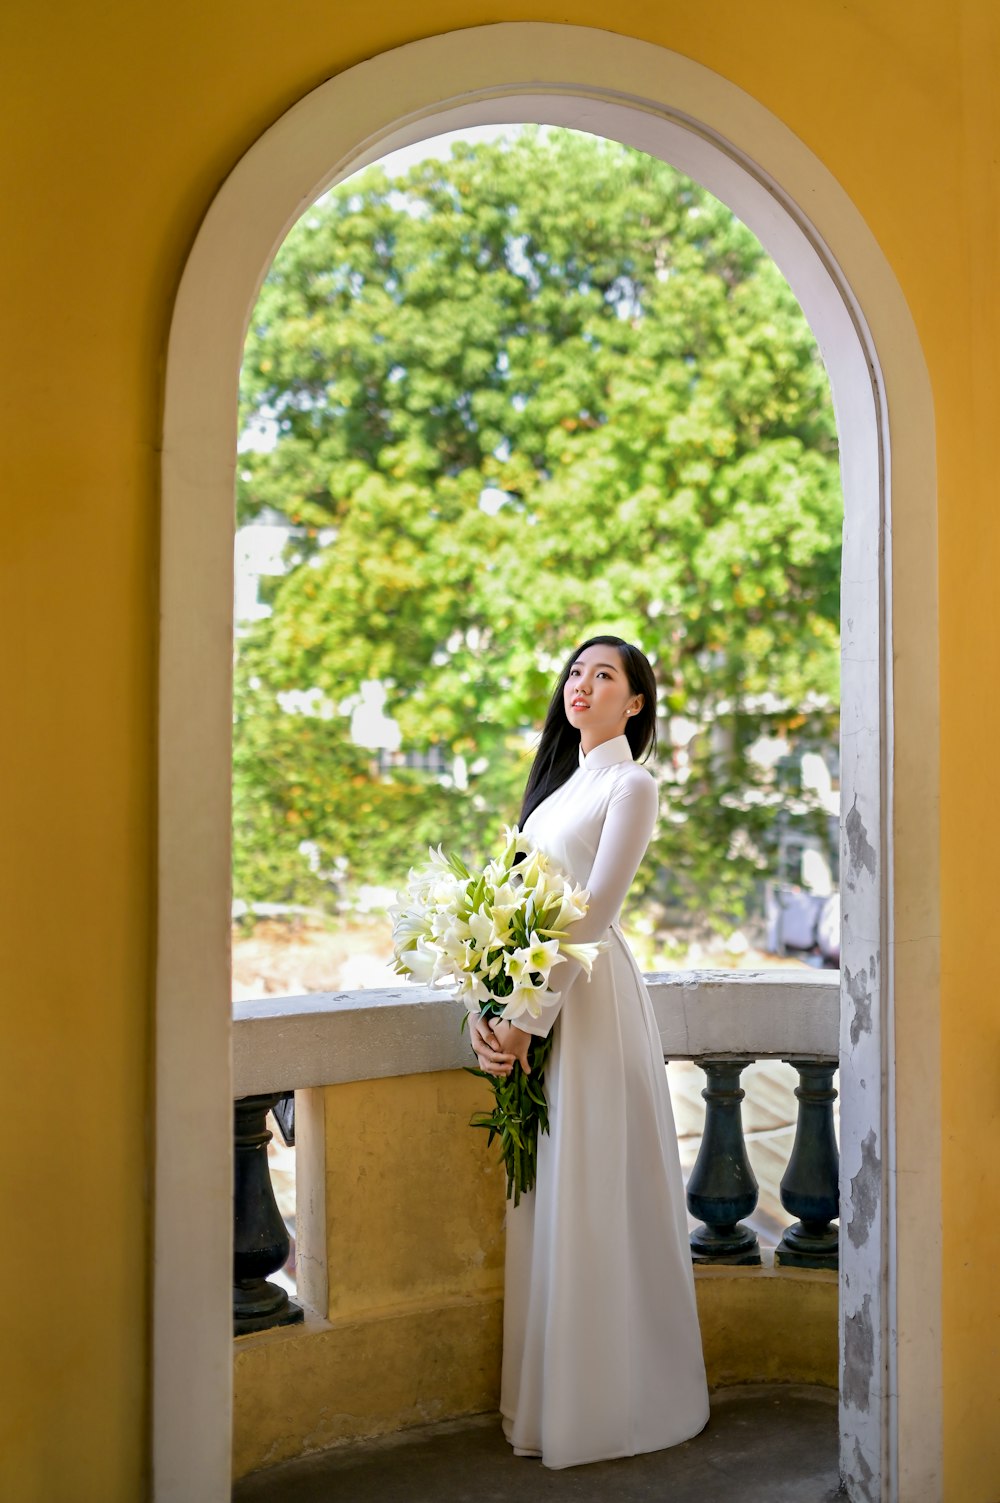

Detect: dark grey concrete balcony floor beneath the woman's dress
233,1386,841,1503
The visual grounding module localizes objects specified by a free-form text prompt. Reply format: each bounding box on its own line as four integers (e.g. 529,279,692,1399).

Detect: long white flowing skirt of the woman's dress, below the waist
501,924,708,1467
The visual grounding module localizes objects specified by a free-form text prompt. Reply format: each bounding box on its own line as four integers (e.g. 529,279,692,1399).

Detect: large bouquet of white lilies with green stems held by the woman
391,827,602,1205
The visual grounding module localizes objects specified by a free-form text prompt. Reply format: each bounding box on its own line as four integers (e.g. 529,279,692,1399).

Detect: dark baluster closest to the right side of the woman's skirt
687,1058,761,1264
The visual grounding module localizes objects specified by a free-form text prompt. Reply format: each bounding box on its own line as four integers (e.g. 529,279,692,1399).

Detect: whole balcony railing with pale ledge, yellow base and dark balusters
233,971,839,1477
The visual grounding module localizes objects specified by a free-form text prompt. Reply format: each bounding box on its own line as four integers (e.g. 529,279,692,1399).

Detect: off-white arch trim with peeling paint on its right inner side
153,24,943,1503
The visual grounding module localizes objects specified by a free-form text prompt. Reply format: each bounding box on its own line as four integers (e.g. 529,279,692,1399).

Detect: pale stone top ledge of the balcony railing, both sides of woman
233,968,839,1096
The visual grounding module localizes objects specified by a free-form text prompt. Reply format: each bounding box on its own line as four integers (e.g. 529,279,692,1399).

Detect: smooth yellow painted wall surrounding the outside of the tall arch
0,0,1000,1503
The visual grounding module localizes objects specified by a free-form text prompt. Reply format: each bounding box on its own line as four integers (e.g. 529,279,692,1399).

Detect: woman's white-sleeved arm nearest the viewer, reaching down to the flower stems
498,767,659,1052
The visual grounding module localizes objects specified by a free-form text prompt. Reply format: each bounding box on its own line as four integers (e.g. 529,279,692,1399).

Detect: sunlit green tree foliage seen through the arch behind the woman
235,131,842,917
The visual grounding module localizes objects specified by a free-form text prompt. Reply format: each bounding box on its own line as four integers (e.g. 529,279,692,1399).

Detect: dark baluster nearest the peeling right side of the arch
774,1060,841,1269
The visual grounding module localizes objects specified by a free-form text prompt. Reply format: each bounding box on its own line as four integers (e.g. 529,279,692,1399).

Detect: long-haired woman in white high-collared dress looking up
472,636,708,1467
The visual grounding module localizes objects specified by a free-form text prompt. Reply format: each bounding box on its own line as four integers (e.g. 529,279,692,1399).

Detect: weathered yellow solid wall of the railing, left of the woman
233,1070,504,1477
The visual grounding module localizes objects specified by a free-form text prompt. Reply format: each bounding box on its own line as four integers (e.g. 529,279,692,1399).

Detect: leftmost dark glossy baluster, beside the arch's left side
233,1093,302,1336
